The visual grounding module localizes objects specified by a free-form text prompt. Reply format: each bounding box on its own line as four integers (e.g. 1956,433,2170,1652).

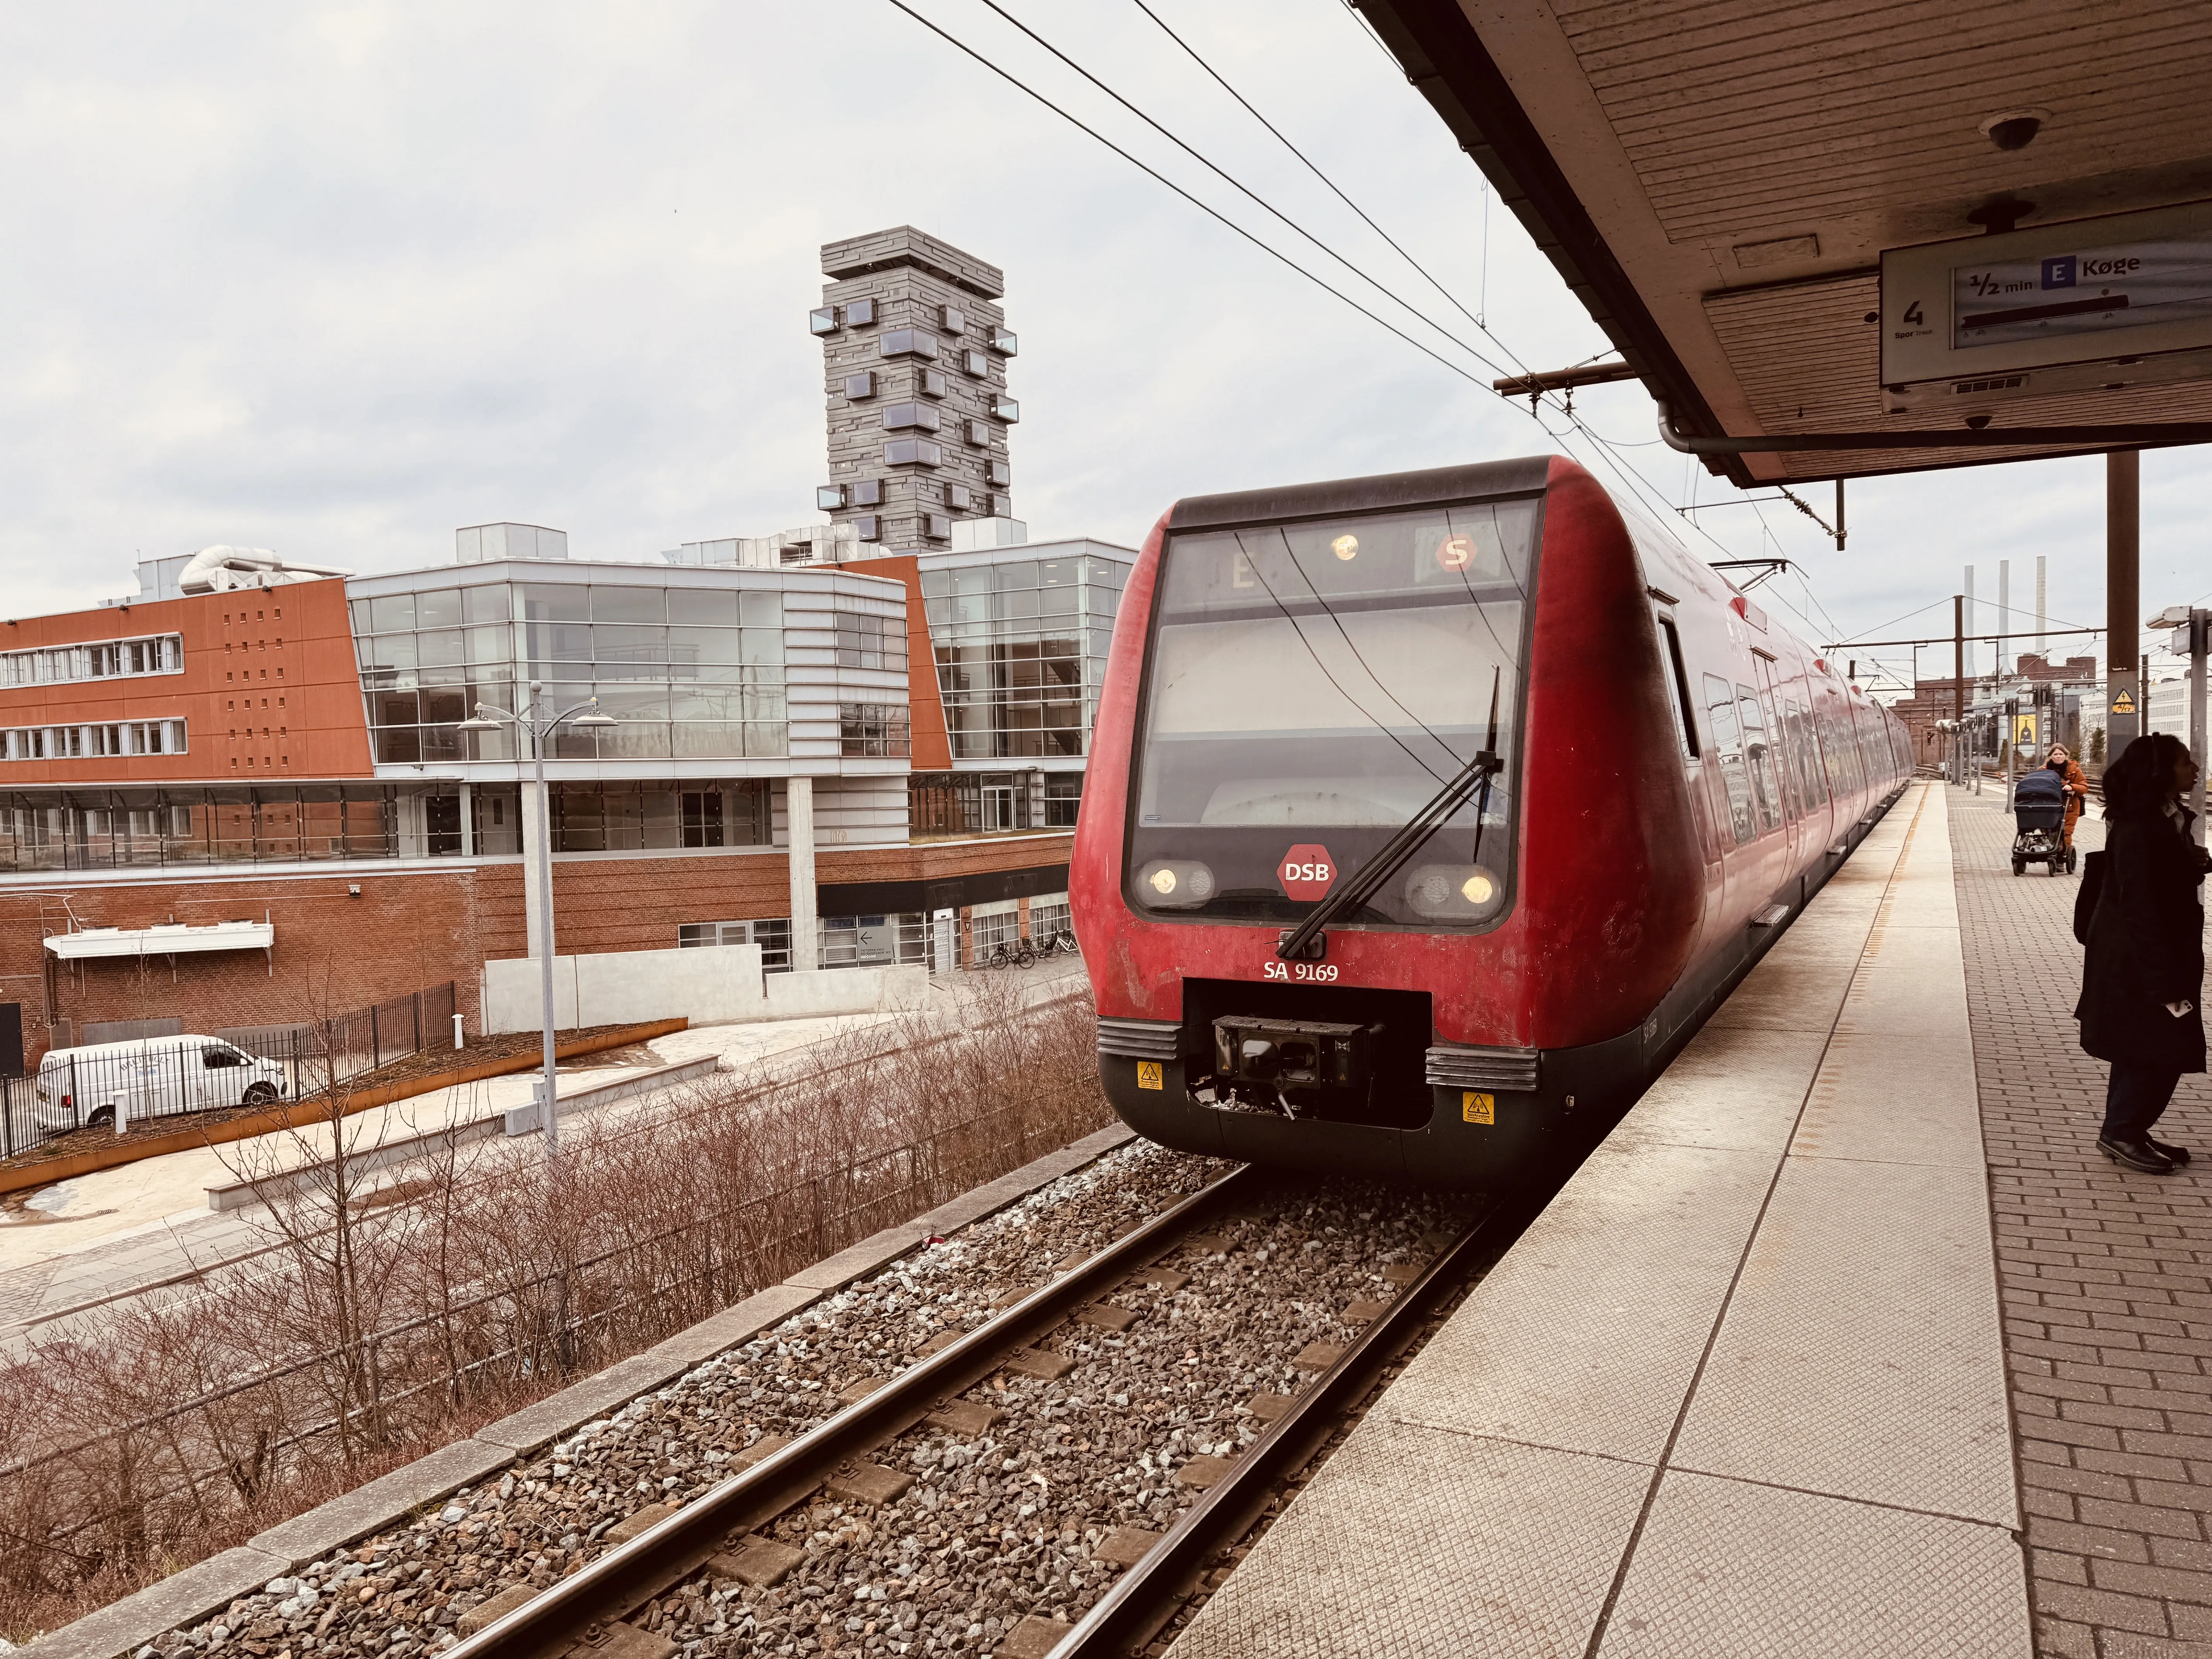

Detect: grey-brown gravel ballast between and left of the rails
139,1144,1475,1659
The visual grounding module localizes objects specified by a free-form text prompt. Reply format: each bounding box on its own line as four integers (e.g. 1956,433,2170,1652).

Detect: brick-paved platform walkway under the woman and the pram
1949,790,2212,1659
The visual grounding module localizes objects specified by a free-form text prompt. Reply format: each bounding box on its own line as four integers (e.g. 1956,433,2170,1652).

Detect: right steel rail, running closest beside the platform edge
1048,1194,1548,1659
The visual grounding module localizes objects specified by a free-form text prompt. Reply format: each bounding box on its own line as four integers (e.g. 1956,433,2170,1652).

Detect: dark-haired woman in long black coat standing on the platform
2075,732,2205,1175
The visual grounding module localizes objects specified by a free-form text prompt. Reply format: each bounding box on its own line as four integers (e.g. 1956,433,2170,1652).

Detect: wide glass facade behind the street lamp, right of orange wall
352,582,787,763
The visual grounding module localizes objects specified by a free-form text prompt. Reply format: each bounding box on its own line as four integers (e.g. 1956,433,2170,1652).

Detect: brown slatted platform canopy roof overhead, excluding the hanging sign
1354,0,2212,484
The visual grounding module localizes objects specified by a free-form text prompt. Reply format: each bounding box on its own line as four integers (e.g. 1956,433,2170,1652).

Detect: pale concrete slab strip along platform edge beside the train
1172,785,2035,1659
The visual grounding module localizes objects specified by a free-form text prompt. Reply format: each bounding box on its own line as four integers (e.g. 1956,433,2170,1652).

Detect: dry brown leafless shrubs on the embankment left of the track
0,980,1110,1641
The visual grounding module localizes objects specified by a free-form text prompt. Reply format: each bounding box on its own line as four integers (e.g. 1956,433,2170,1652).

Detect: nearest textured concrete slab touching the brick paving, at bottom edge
1597,1471,2031,1659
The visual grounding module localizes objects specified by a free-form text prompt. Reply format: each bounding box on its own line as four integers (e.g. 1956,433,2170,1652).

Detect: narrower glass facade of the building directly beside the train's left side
922,555,1128,761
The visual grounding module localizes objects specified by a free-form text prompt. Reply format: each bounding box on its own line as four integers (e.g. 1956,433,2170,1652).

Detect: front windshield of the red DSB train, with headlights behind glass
1126,498,1537,929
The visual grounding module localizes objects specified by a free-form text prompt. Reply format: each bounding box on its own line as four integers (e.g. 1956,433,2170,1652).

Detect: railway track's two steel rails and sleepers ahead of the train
442,1170,1517,1659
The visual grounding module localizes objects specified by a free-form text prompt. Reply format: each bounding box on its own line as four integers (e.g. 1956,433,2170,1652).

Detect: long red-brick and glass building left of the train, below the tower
0,539,1128,1064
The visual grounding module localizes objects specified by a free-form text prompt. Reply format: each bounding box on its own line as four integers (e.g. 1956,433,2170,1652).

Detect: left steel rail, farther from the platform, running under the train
442,1166,1259,1659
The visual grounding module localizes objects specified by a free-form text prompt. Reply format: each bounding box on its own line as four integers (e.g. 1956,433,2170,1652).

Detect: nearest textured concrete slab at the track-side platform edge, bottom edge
1170,1416,1652,1659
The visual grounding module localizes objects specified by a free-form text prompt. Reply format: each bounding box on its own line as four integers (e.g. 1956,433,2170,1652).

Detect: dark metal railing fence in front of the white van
0,980,456,1157
